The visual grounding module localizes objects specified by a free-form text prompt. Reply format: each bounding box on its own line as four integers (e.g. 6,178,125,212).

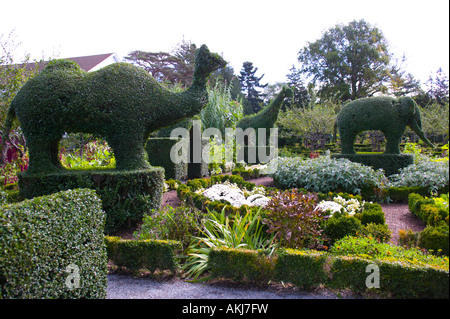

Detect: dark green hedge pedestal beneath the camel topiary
18,167,164,234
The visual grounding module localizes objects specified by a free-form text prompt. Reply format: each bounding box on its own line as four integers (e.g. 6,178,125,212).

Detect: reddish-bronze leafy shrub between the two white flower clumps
264,189,326,248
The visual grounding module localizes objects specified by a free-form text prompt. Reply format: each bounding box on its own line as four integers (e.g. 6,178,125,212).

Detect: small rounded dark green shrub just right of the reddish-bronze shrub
324,216,362,245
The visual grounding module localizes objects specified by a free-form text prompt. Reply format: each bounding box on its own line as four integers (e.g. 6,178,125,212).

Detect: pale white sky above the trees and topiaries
0,0,449,84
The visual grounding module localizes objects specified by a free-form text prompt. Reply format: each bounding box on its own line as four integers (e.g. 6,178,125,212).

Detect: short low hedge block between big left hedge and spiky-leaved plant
105,237,181,272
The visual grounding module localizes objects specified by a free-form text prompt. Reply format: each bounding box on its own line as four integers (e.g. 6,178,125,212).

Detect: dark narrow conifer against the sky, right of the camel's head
238,61,268,115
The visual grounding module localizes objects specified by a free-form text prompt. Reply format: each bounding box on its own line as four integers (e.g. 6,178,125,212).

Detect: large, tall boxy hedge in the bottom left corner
0,189,107,299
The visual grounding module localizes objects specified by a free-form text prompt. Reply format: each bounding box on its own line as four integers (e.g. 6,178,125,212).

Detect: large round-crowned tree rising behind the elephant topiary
298,20,391,101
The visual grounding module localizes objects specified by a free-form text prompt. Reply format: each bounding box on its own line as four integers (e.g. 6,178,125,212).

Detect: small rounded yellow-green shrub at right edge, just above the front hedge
418,223,449,256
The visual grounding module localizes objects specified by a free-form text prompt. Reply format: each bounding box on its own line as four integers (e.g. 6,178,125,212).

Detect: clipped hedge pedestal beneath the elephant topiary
331,154,414,176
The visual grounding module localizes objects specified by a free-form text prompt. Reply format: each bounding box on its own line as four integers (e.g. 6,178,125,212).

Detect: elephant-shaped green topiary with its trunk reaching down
334,97,434,154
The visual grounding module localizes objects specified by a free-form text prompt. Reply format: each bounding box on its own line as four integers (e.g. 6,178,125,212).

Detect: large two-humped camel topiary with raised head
3,45,226,174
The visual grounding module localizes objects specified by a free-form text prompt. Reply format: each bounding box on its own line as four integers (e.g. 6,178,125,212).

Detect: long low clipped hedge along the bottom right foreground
209,248,449,298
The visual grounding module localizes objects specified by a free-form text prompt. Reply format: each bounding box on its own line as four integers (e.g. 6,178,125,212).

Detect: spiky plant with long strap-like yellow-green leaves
183,209,275,281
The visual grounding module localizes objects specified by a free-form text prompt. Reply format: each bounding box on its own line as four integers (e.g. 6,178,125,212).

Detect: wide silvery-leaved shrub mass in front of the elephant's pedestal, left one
270,156,386,196
